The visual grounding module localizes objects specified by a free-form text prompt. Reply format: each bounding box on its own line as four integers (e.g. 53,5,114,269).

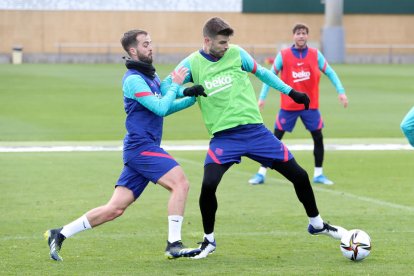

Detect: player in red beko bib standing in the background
249,24,348,185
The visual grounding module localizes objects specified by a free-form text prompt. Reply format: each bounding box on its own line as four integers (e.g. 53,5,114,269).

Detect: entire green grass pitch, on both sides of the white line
0,65,414,275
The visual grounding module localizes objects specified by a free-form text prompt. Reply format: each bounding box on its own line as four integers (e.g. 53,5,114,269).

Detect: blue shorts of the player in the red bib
275,109,324,132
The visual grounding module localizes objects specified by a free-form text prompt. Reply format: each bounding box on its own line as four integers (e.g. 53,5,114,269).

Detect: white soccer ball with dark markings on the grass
340,229,371,261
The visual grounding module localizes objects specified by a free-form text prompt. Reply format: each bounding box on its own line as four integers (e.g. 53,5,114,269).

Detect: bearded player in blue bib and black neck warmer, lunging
45,30,205,261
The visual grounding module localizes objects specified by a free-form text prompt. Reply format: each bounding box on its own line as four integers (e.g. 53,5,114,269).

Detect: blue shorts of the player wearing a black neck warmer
115,145,179,199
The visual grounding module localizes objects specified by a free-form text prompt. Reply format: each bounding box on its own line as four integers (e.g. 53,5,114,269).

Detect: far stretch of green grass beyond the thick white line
0,64,414,141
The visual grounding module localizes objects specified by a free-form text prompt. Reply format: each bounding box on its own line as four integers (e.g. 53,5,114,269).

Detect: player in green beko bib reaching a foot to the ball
166,17,345,259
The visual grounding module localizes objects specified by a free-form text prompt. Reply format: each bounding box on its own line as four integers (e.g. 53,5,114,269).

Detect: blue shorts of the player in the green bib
204,124,293,167
